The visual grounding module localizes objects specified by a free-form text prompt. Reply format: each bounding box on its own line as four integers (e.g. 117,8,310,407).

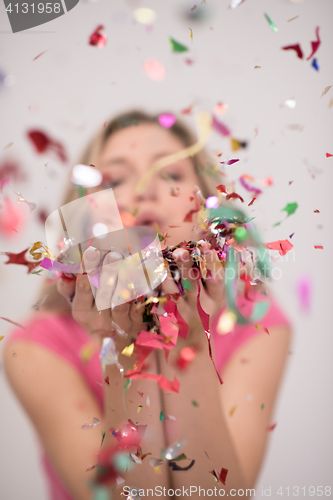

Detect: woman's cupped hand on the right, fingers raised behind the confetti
158,241,226,325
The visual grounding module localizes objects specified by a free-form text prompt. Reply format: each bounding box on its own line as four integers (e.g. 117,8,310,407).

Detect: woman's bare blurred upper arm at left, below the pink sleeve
3,340,105,500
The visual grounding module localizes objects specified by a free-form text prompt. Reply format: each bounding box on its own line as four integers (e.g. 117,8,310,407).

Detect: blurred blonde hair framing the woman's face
40,110,221,314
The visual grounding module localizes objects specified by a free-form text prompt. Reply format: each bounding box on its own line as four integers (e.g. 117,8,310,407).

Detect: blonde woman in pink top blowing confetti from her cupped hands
4,112,290,500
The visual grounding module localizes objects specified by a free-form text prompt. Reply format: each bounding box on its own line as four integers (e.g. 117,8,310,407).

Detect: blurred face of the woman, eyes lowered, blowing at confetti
98,123,199,245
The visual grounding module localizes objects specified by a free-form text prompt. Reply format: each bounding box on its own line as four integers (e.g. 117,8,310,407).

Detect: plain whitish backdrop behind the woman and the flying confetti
0,0,333,500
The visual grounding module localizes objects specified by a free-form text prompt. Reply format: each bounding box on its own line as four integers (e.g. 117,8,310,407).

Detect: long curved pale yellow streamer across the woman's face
136,113,212,194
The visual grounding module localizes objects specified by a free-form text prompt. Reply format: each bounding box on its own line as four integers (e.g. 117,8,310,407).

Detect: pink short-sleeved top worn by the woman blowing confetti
7,298,289,500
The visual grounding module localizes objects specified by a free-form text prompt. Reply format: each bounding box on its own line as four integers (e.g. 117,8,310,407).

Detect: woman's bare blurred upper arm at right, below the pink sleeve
220,325,291,488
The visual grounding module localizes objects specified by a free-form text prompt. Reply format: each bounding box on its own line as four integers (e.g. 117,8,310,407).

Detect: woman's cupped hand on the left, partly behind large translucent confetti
57,248,147,337
